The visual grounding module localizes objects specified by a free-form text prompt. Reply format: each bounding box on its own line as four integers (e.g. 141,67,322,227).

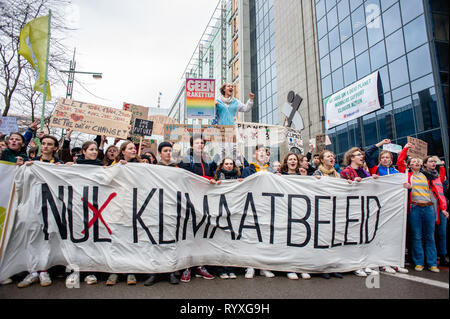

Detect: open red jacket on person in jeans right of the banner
397,147,447,224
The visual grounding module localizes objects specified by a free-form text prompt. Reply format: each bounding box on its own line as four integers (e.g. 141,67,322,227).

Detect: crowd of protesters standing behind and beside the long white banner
0,122,449,287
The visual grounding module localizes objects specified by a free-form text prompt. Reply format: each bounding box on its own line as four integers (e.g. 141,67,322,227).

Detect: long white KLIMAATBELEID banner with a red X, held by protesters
0,162,407,280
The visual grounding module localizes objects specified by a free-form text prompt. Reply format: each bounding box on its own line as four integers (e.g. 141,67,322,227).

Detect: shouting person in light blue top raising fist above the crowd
212,83,255,125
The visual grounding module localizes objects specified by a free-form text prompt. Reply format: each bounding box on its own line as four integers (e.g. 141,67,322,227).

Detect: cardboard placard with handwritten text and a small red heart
50,98,131,139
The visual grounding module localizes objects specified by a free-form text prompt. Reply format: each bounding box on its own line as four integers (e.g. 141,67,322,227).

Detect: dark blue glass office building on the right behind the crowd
315,0,448,165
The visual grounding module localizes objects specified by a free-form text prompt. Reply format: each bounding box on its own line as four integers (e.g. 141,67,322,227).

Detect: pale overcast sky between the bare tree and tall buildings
56,0,218,108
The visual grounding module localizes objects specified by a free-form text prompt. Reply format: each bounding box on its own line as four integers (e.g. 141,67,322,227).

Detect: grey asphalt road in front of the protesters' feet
0,267,449,300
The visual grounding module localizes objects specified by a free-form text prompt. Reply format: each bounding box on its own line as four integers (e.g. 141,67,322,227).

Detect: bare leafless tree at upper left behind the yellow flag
0,0,72,119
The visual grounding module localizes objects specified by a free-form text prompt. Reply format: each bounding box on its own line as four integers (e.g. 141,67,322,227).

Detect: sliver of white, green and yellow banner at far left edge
0,161,16,249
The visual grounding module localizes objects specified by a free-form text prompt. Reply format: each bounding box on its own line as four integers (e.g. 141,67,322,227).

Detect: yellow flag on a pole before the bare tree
19,16,52,101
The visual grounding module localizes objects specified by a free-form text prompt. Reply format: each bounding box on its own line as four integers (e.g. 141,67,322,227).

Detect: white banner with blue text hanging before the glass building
324,71,381,130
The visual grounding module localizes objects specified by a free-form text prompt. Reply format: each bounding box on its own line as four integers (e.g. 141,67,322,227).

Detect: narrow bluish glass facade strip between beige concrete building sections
249,0,278,124
